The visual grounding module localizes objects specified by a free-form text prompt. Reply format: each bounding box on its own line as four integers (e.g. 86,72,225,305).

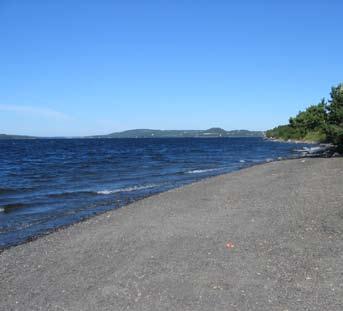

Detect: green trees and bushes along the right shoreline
266,84,343,152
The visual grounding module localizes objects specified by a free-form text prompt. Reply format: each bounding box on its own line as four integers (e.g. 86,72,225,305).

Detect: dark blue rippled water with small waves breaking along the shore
0,138,312,248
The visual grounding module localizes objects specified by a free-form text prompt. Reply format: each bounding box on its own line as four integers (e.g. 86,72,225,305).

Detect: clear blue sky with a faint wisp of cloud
0,0,343,135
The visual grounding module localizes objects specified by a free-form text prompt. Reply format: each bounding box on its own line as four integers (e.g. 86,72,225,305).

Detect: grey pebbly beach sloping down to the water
0,158,343,311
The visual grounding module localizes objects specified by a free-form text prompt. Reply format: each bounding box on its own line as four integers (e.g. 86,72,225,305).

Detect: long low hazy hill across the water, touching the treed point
92,127,264,138
